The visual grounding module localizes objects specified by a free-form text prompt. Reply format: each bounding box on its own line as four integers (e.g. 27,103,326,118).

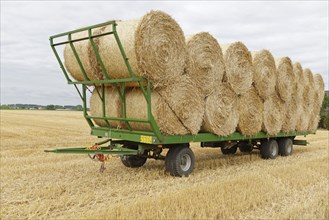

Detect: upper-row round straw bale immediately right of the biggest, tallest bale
186,32,225,96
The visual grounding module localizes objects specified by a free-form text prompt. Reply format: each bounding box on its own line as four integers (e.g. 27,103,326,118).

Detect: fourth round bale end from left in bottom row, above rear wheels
262,93,283,135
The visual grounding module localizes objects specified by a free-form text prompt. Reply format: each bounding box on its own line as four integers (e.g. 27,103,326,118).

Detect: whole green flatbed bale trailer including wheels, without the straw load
46,21,309,177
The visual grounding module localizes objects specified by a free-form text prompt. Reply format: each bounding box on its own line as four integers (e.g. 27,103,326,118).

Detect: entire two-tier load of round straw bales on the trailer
64,11,324,136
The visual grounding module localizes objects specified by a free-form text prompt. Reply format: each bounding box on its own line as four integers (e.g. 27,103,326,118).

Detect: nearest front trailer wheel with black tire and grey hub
166,145,195,177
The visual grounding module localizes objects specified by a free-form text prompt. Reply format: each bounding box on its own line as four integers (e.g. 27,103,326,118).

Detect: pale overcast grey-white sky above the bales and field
0,1,329,105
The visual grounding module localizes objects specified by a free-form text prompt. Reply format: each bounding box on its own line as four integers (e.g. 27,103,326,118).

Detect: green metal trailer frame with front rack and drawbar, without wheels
47,21,309,175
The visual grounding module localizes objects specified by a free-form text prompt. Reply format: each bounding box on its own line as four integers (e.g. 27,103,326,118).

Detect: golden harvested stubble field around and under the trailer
0,110,329,219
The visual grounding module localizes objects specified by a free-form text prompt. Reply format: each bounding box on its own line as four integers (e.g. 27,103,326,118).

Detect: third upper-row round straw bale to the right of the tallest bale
252,50,276,100
